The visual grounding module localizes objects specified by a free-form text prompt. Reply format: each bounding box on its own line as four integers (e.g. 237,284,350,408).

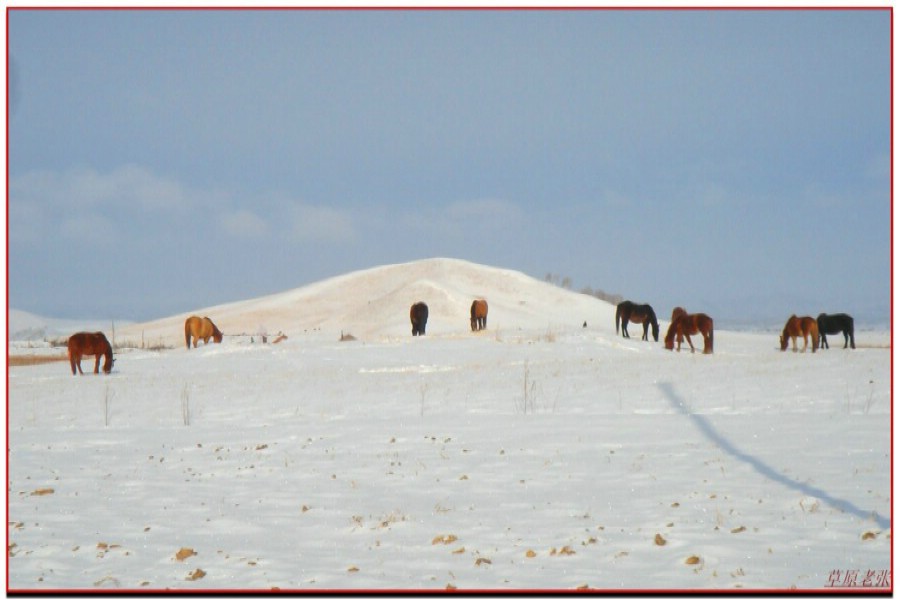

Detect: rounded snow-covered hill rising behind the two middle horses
117,258,616,346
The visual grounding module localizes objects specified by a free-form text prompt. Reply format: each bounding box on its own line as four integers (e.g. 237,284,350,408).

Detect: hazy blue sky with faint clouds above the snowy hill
8,10,891,327
